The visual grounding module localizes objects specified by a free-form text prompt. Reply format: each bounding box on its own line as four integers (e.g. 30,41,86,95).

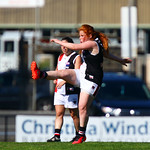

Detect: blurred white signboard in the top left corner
0,0,45,8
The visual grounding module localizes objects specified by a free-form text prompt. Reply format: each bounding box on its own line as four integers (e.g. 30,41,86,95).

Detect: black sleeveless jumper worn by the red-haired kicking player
82,38,103,85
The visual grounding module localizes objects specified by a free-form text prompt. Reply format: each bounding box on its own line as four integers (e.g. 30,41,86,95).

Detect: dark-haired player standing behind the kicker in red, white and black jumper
47,37,82,142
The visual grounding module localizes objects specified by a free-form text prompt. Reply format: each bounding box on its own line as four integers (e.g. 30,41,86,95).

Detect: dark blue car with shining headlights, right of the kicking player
90,72,150,117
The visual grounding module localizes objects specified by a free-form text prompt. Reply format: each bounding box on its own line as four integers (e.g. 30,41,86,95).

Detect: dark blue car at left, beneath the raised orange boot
0,70,53,110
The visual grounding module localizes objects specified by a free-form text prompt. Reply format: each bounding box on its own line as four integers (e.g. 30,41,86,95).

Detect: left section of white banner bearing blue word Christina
16,115,100,142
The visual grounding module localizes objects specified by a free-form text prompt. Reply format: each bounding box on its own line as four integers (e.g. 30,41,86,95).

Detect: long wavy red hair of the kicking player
78,24,108,52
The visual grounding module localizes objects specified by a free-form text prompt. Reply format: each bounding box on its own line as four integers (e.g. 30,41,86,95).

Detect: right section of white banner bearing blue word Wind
100,117,150,142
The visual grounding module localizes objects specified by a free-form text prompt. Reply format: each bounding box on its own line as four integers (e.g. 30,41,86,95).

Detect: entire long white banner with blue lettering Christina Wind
16,115,150,142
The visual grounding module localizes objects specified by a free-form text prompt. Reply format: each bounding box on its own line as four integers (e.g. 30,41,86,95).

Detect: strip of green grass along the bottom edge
0,142,150,150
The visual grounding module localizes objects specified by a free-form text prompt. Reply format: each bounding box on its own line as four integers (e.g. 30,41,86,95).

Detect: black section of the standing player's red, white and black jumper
66,53,80,95
